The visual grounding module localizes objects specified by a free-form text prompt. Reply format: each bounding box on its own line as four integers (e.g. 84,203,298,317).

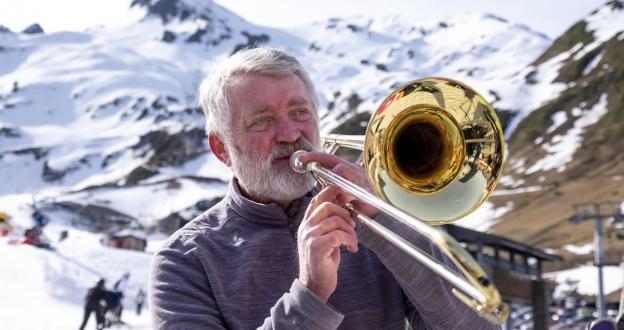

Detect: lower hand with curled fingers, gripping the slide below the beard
297,185,358,302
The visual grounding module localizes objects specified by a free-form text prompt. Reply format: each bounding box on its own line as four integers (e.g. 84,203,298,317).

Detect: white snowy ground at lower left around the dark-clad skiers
0,223,151,330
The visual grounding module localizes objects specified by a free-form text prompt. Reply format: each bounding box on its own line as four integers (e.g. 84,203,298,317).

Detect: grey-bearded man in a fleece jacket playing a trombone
148,48,496,329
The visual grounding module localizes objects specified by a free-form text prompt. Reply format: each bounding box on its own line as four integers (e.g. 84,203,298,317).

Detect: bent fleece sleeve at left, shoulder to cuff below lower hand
148,236,344,330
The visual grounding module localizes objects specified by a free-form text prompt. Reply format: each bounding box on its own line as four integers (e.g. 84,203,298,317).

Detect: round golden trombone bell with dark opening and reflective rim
334,78,504,224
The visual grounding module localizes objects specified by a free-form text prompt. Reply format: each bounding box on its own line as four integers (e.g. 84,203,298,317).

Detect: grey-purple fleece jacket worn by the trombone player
149,184,500,330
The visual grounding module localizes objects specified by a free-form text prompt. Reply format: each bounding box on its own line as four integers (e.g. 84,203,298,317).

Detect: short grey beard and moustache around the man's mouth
230,137,319,202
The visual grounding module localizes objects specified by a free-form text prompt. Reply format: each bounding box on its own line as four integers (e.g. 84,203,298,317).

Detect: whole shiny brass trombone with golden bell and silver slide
290,78,509,324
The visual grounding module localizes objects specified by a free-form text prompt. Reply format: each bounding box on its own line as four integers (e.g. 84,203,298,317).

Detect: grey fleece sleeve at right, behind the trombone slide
358,214,501,329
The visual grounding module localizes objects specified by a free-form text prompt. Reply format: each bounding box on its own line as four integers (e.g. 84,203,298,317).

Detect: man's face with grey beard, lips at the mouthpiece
226,74,319,203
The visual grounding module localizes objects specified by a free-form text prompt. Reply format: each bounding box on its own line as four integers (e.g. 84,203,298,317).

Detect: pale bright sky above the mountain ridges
0,0,606,38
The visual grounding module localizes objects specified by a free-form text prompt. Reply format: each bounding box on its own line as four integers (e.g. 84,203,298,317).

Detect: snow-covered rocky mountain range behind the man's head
0,0,550,232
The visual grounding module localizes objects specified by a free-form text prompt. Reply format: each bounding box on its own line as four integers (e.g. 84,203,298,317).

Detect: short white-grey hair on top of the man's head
199,47,318,141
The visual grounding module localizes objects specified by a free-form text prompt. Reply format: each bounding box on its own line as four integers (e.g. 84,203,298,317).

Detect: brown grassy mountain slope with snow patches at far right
492,1,624,263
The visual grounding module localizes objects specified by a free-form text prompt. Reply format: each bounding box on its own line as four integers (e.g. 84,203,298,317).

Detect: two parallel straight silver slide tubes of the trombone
304,161,487,305
